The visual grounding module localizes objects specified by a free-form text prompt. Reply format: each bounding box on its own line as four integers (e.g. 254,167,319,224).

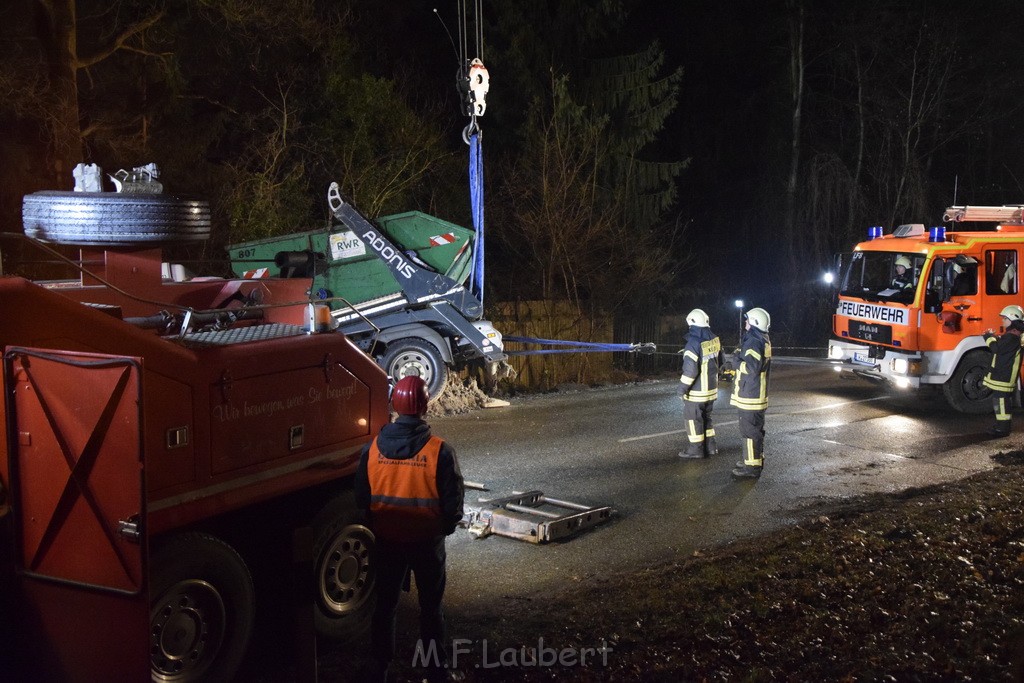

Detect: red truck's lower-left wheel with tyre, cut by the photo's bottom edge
150,532,255,683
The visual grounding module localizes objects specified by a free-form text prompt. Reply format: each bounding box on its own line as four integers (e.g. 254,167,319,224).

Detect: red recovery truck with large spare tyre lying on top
0,193,389,682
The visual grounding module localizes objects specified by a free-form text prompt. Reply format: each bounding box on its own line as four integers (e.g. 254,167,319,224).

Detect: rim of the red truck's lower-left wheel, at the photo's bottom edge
150,579,227,681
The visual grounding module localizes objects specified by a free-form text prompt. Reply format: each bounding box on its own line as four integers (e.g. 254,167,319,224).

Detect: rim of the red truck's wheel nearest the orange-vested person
316,524,374,616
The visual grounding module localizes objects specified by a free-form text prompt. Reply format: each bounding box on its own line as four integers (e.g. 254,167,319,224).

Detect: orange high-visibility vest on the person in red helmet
367,436,444,542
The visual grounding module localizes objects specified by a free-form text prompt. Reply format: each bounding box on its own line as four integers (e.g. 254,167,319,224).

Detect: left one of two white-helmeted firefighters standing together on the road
679,308,722,458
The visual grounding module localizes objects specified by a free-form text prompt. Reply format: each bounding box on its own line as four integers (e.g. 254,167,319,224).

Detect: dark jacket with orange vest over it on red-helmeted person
355,415,464,542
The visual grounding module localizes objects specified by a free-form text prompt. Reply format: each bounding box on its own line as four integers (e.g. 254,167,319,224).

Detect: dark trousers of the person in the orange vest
370,537,446,668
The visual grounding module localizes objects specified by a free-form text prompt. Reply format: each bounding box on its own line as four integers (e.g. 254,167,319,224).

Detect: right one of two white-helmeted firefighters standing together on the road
729,308,771,478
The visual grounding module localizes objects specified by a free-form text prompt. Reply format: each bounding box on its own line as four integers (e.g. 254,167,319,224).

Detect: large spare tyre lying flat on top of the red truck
22,191,210,246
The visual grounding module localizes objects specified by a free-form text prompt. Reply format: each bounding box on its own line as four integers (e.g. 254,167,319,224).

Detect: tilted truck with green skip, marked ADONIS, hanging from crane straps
228,183,507,398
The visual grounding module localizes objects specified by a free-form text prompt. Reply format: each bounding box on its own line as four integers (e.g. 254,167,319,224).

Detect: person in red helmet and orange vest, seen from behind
355,375,464,681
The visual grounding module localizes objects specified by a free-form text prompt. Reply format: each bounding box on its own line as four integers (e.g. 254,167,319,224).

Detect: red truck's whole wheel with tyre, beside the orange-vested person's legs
313,492,375,640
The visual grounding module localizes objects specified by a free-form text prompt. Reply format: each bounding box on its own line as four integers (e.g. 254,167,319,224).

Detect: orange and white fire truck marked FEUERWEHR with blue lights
828,205,1024,414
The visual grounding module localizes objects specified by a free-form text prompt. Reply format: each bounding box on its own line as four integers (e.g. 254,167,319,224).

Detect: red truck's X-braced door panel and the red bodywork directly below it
0,347,151,683
